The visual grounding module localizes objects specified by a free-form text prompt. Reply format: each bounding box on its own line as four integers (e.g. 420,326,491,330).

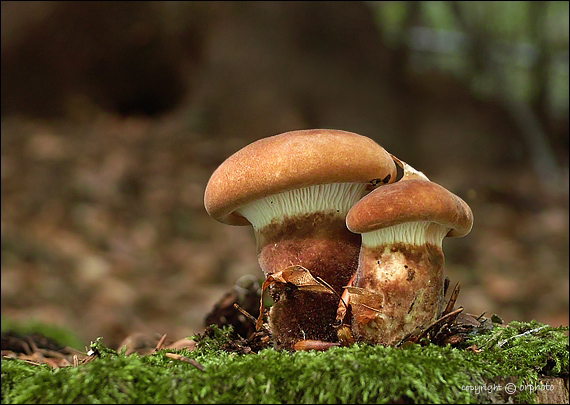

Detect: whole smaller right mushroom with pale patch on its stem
339,178,473,346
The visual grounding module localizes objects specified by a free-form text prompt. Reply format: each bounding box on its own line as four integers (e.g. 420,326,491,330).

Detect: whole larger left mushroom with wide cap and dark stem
204,129,396,348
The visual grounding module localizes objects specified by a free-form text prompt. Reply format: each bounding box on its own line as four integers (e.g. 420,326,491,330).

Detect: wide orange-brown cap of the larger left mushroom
204,129,396,225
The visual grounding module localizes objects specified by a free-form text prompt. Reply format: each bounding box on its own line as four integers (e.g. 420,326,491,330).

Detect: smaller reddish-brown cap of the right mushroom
346,179,473,237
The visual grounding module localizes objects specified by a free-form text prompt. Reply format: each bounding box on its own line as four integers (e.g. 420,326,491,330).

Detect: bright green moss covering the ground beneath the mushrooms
2,322,568,404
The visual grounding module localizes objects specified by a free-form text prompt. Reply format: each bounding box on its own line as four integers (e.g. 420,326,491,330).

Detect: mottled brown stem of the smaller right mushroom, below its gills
350,243,444,345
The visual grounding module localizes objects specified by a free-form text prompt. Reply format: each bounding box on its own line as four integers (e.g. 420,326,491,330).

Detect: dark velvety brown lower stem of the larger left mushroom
256,213,360,348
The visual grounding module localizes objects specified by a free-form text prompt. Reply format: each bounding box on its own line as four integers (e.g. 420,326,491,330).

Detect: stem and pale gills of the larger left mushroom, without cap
237,183,366,348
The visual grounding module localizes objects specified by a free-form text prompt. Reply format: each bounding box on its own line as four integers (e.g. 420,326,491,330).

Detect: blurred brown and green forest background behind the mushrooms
1,1,569,347
